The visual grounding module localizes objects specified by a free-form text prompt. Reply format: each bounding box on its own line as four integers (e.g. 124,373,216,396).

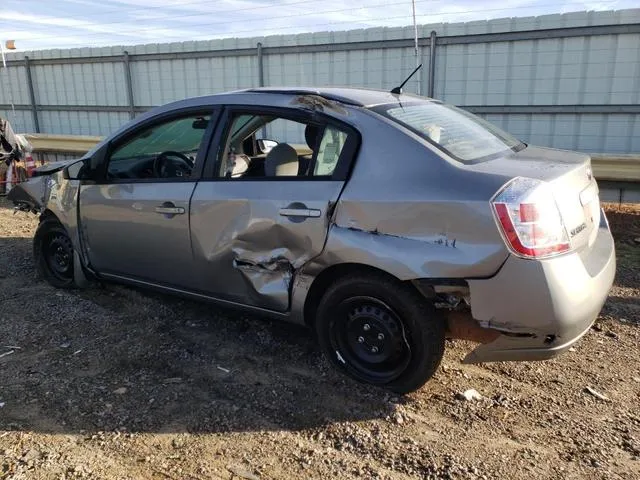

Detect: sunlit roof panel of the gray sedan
238,87,430,107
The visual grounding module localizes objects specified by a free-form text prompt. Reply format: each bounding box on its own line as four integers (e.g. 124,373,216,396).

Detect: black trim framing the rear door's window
201,105,362,183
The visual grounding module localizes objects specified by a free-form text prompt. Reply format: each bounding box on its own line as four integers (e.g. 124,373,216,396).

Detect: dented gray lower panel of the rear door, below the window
190,180,343,312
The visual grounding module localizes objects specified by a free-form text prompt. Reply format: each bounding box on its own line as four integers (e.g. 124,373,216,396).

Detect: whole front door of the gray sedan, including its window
80,112,212,287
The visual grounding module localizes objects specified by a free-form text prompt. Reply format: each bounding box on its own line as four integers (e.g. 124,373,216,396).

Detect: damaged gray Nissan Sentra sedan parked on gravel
10,88,615,393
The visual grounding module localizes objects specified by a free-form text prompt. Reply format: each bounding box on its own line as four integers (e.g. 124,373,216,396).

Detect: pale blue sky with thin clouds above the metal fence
0,0,640,50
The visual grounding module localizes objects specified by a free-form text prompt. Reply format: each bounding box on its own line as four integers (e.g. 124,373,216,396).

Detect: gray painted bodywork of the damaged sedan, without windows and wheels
3,88,615,362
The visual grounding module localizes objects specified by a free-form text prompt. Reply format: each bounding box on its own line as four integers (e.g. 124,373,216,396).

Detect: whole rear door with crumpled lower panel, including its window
191,107,359,311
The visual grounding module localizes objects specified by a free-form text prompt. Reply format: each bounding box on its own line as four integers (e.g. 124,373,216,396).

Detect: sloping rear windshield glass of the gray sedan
372,102,525,163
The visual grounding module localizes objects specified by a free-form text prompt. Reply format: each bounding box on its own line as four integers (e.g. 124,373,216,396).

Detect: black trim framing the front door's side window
96,105,220,185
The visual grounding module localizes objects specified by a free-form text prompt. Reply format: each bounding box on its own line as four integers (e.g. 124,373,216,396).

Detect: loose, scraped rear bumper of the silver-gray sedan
464,213,616,363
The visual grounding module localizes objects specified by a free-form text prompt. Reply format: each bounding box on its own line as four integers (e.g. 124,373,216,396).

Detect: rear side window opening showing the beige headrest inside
217,113,347,179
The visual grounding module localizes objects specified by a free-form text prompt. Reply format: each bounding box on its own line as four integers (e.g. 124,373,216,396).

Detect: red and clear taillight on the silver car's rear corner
492,177,571,258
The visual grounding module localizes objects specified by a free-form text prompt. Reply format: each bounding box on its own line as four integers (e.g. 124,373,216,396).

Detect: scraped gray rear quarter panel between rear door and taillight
308,109,508,280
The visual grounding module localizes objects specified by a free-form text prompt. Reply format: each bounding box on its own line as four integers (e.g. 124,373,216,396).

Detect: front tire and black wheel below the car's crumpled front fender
33,217,75,288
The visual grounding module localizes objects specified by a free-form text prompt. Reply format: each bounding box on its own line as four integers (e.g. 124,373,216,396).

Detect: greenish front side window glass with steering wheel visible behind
107,115,211,180
